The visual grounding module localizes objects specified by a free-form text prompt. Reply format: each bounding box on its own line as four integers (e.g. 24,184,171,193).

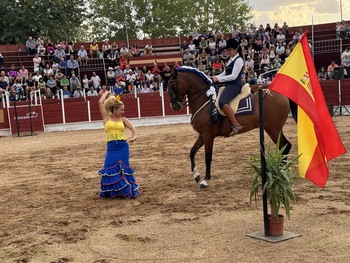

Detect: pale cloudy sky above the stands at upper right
247,0,350,27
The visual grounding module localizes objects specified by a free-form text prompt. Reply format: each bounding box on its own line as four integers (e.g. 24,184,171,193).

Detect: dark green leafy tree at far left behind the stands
0,0,85,44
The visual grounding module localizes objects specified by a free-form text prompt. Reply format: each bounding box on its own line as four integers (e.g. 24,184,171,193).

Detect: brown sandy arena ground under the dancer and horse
0,117,350,263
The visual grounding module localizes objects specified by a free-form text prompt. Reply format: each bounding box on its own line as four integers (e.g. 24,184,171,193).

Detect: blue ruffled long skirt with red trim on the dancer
98,140,140,198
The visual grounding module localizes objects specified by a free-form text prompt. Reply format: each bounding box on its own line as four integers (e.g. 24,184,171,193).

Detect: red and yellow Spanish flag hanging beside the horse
269,33,346,188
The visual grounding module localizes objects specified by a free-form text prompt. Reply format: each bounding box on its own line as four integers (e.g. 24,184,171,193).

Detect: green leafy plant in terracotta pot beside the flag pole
249,139,300,236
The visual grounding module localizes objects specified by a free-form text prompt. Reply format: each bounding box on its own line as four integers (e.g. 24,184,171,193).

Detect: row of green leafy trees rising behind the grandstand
0,0,252,43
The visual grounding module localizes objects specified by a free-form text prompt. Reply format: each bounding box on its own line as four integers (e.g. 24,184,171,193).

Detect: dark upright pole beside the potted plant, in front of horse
258,84,269,237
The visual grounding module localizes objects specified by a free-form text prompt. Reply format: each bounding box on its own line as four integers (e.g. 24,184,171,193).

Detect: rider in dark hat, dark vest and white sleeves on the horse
213,38,244,136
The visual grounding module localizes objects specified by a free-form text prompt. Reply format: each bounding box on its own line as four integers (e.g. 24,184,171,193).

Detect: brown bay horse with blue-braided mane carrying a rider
168,67,292,189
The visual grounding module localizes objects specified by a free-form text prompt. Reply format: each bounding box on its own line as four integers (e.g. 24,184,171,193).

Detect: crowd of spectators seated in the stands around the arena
0,21,350,100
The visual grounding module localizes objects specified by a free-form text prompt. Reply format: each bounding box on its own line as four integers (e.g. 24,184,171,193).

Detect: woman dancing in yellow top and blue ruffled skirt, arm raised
98,91,140,198
